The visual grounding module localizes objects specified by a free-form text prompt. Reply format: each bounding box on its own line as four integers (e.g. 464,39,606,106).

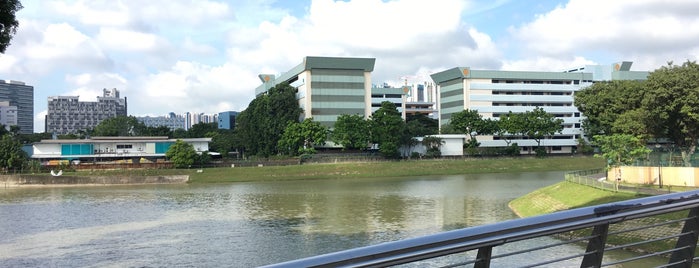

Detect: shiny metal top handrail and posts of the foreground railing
266,190,699,267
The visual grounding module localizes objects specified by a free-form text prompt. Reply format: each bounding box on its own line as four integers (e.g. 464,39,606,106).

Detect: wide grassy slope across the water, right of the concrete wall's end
188,157,604,183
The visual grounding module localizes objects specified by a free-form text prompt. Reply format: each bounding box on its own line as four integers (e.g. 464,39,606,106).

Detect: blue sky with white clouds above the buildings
0,0,699,132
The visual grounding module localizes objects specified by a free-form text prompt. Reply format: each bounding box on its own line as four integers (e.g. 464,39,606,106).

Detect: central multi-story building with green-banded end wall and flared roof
255,57,376,127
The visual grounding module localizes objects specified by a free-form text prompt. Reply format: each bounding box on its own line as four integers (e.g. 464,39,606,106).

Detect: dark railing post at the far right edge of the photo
668,207,699,267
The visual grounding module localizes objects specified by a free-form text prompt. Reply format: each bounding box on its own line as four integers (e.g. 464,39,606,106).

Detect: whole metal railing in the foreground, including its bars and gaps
267,190,699,267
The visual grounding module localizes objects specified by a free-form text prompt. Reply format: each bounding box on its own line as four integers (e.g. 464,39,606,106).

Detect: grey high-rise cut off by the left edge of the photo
0,80,34,134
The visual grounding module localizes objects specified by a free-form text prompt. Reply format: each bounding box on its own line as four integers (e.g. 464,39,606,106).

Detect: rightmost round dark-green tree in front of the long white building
522,107,563,153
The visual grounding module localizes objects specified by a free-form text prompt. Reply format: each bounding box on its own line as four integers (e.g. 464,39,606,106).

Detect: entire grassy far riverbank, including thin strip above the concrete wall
4,156,605,185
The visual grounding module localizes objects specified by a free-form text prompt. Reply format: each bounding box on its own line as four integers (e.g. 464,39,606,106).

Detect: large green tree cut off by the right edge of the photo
642,61,699,166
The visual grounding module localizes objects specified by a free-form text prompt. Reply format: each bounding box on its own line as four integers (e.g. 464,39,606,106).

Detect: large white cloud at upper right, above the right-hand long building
511,0,699,70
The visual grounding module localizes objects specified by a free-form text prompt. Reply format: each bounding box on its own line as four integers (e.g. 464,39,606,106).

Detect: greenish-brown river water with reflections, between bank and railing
0,172,668,267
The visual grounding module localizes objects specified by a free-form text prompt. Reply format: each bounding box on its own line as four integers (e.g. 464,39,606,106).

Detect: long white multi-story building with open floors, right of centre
432,62,648,153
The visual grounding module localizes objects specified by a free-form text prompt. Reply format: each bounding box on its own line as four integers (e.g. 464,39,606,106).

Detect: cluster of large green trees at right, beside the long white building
575,61,699,166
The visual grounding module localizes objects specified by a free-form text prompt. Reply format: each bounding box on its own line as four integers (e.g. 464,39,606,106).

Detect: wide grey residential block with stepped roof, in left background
46,88,127,134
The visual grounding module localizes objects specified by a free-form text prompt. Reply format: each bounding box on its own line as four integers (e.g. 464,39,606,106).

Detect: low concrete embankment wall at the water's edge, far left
0,175,189,187
